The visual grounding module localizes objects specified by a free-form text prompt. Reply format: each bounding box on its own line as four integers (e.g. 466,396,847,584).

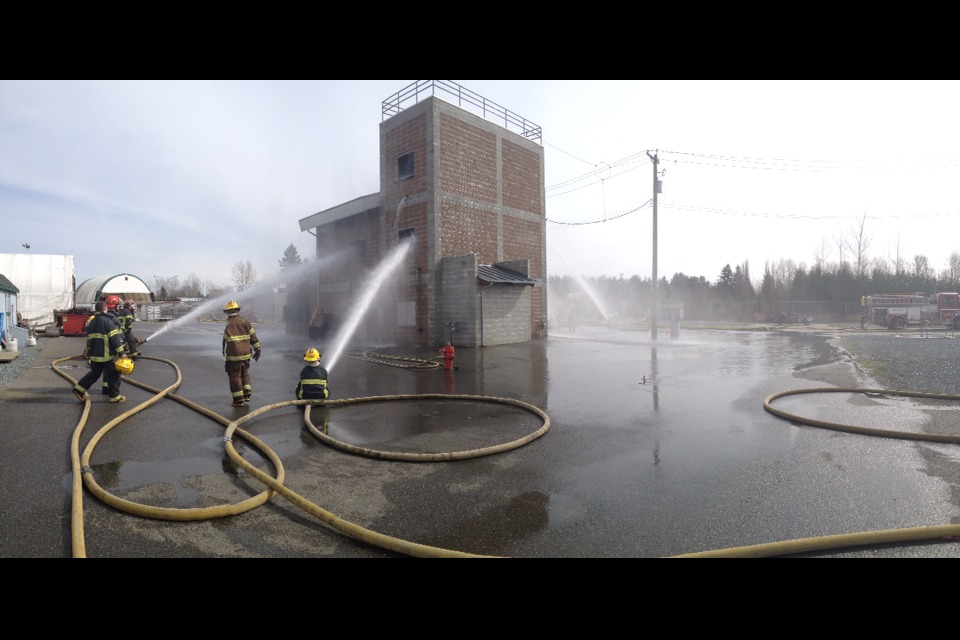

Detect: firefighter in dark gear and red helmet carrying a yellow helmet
73,296,132,403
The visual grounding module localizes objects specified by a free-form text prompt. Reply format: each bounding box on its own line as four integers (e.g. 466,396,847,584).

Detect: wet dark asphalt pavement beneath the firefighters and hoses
0,322,960,558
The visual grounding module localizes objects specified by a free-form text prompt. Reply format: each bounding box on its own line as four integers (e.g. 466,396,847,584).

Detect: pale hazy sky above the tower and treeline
0,80,960,288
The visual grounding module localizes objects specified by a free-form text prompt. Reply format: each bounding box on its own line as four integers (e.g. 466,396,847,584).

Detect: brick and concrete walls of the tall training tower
311,92,547,346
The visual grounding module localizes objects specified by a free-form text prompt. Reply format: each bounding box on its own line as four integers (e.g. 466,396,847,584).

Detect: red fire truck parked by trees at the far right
860,293,960,329
